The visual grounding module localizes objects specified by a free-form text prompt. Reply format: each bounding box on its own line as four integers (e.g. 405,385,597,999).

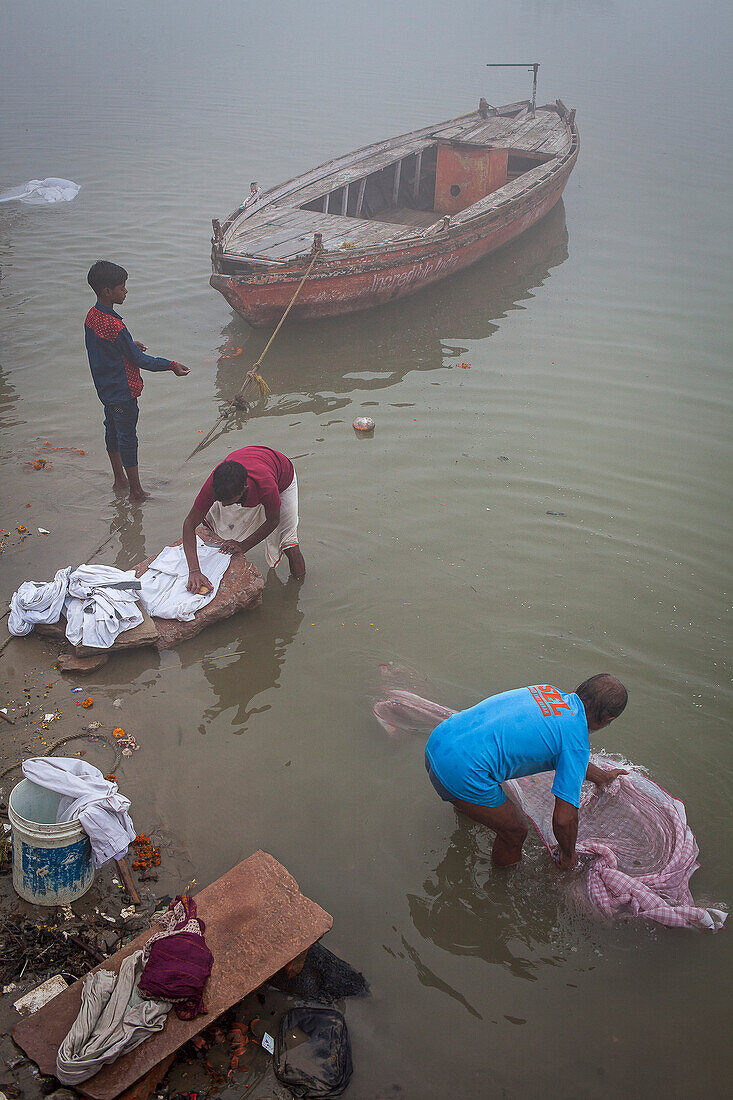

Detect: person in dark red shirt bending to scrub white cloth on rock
183,447,305,592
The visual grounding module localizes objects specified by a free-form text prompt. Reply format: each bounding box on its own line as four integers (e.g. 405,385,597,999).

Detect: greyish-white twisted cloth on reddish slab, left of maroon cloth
56,950,171,1085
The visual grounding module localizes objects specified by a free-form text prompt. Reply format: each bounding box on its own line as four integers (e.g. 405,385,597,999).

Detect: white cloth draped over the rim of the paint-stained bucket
23,757,135,867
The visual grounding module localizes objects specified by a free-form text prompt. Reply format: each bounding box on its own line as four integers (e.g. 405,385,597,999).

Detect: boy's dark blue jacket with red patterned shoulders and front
84,301,173,405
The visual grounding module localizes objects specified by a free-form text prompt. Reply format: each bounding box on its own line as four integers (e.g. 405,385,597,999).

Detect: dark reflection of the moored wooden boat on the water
208,201,568,424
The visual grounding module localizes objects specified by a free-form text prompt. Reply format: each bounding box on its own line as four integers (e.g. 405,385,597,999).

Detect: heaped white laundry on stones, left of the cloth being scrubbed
8,565,143,649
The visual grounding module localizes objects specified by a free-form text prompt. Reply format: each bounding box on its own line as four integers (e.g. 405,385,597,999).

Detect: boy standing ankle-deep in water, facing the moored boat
84,260,188,501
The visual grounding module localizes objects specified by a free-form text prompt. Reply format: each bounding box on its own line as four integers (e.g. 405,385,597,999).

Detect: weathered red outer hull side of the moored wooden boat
210,144,577,328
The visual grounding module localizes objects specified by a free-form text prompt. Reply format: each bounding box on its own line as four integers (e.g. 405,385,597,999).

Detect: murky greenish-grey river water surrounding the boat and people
0,0,733,1098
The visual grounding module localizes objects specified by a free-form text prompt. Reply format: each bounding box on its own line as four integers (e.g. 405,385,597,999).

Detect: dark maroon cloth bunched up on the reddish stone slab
138,894,214,1020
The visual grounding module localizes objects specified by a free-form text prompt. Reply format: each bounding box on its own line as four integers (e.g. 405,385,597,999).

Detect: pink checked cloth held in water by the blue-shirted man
373,678,727,932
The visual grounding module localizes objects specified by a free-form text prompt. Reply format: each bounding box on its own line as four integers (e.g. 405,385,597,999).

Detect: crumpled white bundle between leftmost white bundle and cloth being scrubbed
64,565,143,649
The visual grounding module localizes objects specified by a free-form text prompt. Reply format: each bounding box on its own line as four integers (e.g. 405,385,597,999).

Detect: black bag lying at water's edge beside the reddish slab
274,1004,353,1097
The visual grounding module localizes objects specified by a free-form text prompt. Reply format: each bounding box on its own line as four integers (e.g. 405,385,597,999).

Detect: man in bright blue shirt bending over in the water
425,672,628,870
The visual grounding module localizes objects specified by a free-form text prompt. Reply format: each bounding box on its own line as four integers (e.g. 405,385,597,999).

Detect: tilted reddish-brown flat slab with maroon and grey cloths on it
13,851,333,1100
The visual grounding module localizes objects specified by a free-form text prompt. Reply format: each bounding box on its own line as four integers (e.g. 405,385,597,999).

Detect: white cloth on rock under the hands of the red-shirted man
140,537,231,623
